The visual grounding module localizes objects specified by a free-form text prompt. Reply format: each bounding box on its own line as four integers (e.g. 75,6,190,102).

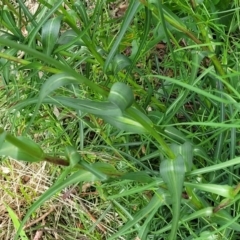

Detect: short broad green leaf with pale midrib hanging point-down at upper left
42,16,62,56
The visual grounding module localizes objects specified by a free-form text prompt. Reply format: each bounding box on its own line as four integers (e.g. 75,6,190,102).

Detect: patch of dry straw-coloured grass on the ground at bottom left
0,160,120,240
